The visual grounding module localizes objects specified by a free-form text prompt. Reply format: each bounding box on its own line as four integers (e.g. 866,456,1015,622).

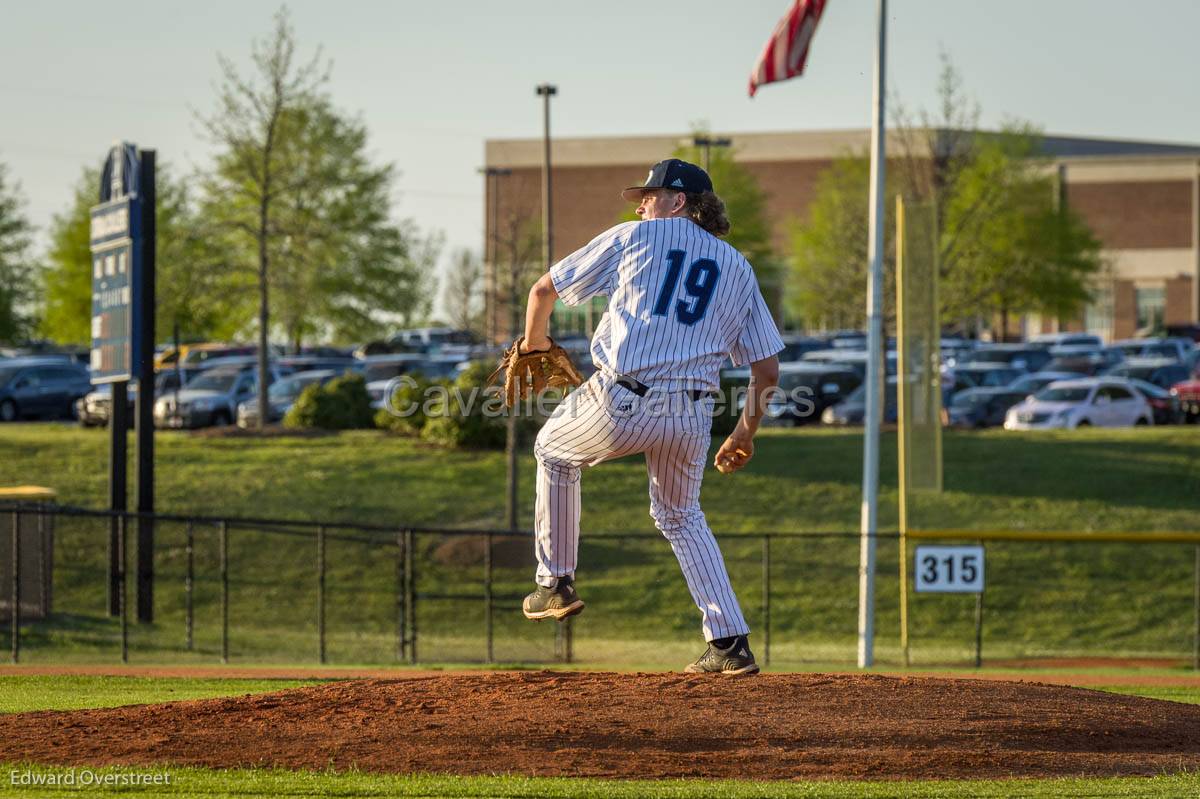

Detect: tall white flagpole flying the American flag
858,0,888,668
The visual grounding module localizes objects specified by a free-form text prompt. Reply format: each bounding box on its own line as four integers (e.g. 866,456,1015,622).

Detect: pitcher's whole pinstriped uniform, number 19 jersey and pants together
534,211,784,641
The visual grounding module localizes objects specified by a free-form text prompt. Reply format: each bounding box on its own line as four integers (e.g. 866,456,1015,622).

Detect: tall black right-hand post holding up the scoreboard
131,150,156,623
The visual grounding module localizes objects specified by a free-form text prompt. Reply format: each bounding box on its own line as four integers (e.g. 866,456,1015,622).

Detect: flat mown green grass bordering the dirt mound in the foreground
0,674,1200,799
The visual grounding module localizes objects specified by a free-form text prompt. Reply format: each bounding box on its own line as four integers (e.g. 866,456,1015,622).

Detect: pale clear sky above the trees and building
0,0,1200,309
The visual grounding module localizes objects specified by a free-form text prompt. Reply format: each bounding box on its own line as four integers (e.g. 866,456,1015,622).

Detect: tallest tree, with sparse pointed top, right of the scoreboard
203,10,438,423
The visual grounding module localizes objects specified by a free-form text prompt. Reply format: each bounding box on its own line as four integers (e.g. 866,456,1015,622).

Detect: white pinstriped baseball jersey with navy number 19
550,217,784,390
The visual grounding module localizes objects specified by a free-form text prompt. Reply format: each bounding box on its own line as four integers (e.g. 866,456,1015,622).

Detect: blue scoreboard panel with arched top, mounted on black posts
91,143,142,383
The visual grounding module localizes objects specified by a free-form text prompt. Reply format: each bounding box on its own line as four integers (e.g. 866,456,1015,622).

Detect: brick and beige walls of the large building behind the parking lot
484,130,1200,338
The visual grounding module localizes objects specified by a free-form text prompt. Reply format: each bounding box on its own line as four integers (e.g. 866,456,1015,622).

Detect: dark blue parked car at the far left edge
0,358,91,421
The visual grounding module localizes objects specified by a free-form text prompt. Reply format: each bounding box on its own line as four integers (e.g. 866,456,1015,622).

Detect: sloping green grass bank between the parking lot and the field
0,425,1200,667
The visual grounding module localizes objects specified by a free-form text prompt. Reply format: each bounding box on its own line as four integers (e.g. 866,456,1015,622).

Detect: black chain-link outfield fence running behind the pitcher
7,505,1200,667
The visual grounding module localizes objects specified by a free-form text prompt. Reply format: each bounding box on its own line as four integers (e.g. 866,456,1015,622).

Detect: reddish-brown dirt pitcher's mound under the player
0,672,1200,780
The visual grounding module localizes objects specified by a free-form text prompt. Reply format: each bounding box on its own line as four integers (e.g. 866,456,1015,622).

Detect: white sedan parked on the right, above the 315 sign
1004,378,1154,429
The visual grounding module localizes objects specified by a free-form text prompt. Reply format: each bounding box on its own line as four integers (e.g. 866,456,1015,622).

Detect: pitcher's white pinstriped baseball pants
534,372,749,641
